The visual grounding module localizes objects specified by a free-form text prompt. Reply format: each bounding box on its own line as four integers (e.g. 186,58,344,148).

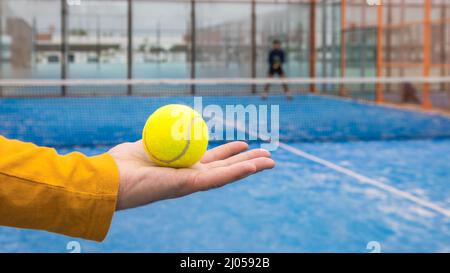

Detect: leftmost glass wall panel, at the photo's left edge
0,0,61,79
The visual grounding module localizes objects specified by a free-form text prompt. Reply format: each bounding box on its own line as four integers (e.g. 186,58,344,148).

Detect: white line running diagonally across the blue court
224,118,450,218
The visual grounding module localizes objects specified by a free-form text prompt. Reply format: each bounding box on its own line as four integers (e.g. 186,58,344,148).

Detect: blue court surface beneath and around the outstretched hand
0,95,450,252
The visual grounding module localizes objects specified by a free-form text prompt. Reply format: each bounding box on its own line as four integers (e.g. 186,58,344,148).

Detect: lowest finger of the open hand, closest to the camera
193,157,275,191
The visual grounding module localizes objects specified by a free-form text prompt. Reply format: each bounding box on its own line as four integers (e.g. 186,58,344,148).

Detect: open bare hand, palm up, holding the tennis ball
108,141,275,210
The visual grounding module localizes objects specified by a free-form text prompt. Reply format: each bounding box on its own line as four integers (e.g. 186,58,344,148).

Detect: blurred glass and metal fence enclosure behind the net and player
0,0,450,108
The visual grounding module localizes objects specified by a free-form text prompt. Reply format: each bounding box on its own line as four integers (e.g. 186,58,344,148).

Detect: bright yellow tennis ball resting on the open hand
142,104,208,168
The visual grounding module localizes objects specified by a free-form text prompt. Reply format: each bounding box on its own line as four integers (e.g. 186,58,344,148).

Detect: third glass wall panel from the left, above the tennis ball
133,1,191,78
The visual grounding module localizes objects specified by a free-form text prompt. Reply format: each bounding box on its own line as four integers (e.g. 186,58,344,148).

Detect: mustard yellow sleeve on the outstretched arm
0,136,119,241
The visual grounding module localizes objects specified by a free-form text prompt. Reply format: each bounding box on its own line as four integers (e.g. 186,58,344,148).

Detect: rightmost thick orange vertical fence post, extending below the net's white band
422,0,432,109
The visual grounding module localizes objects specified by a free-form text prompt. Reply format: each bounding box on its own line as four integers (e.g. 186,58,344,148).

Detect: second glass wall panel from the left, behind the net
68,0,127,79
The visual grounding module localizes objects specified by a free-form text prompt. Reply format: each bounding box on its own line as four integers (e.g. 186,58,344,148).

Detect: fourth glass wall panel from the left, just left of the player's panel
196,1,251,78
